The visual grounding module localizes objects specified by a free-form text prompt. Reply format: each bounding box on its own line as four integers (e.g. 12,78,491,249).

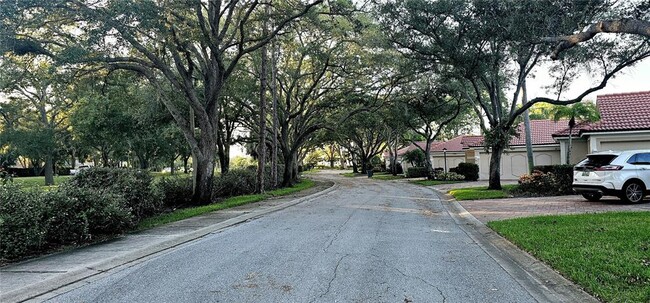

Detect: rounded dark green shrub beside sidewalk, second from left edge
41,185,133,244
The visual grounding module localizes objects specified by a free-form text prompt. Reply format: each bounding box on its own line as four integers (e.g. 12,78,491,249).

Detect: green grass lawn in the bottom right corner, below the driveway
488,212,650,302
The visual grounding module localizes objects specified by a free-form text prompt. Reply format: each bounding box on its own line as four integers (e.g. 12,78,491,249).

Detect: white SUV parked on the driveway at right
573,150,650,203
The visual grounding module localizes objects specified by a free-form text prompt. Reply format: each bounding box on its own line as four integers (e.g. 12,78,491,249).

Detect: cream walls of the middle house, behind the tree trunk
477,144,560,180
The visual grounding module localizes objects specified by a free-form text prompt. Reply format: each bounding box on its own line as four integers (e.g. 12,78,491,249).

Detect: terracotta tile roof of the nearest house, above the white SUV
554,91,650,137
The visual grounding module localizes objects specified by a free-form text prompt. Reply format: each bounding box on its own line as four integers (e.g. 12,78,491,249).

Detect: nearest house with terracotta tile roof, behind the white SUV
553,91,650,164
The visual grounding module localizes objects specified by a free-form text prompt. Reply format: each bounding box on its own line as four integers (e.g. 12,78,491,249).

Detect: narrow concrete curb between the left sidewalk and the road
0,183,339,302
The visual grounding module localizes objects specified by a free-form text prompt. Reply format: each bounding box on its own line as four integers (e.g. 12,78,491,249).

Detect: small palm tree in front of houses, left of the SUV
547,102,600,164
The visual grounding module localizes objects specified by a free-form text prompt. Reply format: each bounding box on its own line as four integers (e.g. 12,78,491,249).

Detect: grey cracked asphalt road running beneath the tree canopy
45,175,537,302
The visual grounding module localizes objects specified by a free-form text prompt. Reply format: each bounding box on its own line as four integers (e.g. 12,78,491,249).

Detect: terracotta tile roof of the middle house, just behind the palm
469,120,569,147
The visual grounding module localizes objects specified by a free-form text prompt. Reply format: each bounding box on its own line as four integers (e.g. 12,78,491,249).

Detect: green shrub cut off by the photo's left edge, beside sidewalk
0,184,47,260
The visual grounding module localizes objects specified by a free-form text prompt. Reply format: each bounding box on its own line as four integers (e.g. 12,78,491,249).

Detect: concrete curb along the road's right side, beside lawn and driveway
433,194,600,303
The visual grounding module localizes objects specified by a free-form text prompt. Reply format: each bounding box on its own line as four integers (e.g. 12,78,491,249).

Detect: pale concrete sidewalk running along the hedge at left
0,182,336,303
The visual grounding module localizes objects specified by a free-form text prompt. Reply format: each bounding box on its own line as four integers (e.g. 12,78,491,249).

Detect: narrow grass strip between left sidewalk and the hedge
135,179,316,231
